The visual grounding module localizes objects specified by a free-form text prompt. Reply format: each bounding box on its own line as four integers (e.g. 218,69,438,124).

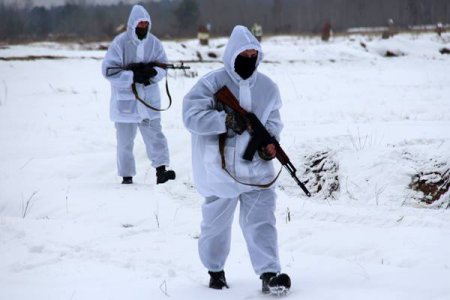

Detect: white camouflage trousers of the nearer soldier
198,189,281,275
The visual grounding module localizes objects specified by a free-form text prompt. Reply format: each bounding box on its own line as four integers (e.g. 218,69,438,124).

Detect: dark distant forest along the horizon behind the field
0,0,450,42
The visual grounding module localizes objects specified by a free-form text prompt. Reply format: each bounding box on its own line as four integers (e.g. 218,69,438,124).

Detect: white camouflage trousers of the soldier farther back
115,118,170,177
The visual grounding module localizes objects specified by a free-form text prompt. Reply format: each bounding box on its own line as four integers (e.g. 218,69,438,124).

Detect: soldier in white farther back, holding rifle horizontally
102,5,175,184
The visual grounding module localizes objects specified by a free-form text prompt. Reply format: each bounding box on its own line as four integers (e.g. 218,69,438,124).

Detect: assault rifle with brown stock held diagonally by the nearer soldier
214,86,311,197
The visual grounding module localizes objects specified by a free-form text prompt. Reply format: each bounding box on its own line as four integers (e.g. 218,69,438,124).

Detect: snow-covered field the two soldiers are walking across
0,34,450,300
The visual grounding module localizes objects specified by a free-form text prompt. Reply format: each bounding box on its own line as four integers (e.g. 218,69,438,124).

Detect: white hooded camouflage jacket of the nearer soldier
183,26,283,198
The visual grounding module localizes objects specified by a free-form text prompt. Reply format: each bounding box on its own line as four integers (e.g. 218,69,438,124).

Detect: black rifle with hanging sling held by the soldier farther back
106,61,191,111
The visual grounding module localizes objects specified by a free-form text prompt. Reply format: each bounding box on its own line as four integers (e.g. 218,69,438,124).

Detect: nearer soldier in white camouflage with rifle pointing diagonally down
183,26,290,293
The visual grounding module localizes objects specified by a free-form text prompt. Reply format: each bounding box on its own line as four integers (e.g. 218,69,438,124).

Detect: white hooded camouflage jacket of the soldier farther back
102,5,167,123
